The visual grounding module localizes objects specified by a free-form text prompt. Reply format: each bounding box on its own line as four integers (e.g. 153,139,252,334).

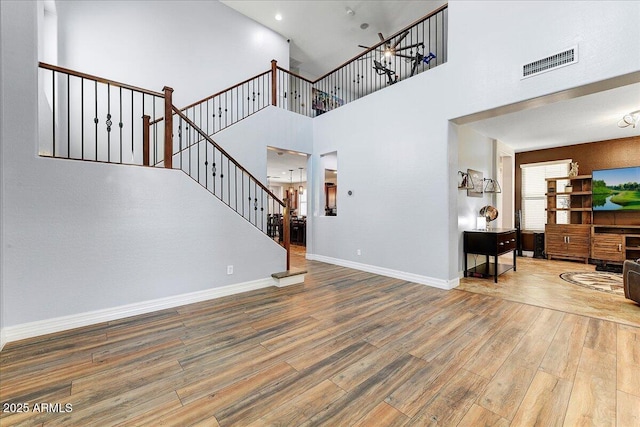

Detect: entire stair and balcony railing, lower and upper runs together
39,5,448,283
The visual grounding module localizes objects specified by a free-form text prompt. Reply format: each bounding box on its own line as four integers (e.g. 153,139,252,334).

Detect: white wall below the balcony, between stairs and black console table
307,64,451,287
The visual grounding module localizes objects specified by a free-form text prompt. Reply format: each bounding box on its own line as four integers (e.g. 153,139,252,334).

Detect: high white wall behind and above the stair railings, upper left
56,0,289,107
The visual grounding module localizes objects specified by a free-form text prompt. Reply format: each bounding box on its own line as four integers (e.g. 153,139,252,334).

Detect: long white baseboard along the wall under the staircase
0,277,275,350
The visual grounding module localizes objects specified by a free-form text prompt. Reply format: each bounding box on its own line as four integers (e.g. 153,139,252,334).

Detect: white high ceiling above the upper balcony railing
221,0,446,79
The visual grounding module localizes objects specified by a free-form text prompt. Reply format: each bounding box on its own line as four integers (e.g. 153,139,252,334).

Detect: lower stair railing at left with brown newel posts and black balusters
39,63,304,283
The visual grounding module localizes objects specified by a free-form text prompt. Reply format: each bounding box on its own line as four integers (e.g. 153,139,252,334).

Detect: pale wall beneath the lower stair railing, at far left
0,1,285,342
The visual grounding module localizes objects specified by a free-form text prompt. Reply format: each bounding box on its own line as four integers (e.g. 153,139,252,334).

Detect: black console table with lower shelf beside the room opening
464,228,516,283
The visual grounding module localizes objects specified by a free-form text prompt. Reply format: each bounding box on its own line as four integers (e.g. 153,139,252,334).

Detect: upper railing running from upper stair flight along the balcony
171,5,448,130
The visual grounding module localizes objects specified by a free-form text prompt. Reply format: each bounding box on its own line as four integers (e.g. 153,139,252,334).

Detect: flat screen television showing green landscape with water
591,166,640,212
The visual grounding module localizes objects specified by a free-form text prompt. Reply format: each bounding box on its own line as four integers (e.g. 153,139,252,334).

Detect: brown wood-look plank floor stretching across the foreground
0,251,640,427
